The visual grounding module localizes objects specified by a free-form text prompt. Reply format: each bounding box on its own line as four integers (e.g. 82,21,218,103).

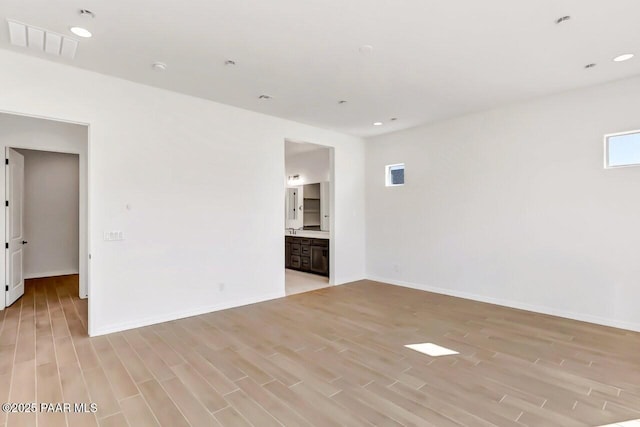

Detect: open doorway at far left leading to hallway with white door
0,113,88,330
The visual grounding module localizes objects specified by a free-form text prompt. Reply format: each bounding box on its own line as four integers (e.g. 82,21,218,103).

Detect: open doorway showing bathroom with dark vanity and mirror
284,141,334,295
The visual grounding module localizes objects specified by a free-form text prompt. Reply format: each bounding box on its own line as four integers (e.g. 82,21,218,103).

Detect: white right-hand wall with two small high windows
366,78,640,330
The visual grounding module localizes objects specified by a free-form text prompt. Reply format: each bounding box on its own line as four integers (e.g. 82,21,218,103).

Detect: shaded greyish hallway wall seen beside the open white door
16,149,79,279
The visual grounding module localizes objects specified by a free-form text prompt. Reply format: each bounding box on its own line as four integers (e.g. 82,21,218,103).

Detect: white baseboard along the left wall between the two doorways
89,291,285,337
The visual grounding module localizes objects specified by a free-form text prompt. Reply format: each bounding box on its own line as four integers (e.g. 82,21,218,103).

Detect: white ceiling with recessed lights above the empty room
0,0,640,136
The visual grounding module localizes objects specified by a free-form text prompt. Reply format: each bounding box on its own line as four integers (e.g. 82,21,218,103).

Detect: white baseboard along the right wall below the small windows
368,276,640,332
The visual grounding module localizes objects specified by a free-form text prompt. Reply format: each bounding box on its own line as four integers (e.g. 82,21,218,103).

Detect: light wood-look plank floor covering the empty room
0,276,640,427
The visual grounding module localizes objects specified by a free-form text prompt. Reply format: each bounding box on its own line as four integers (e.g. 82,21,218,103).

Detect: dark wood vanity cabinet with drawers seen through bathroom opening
284,236,329,277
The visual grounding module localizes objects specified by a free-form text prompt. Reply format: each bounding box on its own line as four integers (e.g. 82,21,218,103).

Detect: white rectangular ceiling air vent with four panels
7,20,78,59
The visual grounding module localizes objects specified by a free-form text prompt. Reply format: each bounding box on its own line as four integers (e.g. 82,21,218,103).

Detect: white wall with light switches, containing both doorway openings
0,51,364,335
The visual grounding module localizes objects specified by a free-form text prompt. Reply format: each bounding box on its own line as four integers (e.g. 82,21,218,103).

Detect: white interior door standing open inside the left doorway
5,148,27,306
